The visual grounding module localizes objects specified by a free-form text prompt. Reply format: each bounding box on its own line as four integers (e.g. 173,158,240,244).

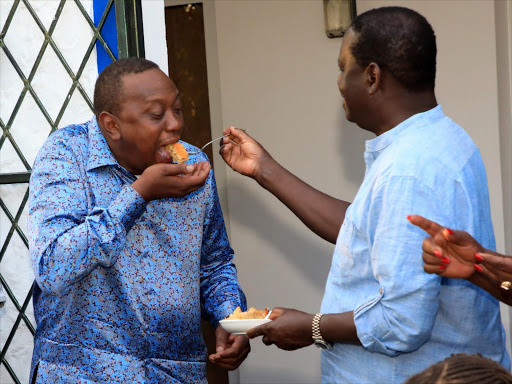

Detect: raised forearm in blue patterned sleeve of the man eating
29,187,145,294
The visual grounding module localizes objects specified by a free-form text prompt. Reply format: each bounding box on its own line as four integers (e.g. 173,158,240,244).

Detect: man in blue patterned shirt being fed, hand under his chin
28,59,250,384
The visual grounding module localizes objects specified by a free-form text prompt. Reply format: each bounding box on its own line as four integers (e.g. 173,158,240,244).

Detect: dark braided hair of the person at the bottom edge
404,353,512,384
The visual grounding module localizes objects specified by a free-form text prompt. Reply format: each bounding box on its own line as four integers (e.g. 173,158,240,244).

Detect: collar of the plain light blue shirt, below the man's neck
366,105,444,152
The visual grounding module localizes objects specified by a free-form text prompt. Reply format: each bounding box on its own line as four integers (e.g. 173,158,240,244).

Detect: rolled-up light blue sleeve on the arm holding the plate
354,177,450,356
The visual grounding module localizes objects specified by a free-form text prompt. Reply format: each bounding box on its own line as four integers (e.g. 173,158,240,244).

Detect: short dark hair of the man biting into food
94,57,159,117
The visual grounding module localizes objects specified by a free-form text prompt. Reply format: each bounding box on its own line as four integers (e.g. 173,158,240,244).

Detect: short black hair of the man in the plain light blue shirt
350,7,437,92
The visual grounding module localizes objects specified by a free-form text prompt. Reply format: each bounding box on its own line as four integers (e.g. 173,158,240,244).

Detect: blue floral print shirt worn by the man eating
28,118,246,384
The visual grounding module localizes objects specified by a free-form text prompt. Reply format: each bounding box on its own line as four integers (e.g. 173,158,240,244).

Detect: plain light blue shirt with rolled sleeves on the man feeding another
321,106,510,384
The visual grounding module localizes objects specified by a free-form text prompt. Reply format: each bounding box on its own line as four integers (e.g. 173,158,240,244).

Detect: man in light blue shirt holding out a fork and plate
221,7,510,384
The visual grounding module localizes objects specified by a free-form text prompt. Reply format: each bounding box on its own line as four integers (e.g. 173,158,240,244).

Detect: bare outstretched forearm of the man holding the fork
255,159,350,244
